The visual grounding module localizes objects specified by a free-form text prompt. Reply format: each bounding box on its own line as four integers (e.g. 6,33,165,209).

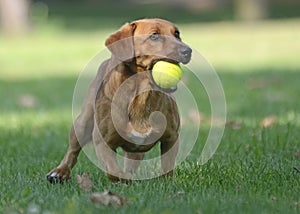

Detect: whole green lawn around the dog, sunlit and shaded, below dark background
0,17,300,214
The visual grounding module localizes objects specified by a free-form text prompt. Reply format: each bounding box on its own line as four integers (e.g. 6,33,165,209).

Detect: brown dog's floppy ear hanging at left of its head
105,23,136,62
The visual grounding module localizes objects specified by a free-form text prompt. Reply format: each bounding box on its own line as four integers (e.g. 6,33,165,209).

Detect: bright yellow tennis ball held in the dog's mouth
152,61,182,88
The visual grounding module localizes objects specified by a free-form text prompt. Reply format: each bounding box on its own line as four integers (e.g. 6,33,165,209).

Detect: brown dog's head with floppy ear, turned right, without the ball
105,19,192,91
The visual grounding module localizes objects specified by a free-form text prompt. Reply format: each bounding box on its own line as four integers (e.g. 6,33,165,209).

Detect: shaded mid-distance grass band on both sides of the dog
0,69,300,119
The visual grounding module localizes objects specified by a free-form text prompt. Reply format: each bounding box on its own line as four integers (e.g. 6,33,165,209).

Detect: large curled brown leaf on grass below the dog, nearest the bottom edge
90,191,131,208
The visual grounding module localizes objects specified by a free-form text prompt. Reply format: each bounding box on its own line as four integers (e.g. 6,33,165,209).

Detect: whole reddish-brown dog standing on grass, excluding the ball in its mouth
47,19,192,183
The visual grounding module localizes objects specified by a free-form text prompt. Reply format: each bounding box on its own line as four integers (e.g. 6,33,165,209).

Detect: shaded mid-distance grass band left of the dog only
0,77,76,113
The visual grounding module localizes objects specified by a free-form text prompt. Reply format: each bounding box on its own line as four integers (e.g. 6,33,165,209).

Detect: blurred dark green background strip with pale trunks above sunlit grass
0,0,300,33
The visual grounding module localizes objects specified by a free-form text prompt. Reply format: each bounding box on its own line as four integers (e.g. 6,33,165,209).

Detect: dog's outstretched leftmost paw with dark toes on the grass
46,165,70,184
